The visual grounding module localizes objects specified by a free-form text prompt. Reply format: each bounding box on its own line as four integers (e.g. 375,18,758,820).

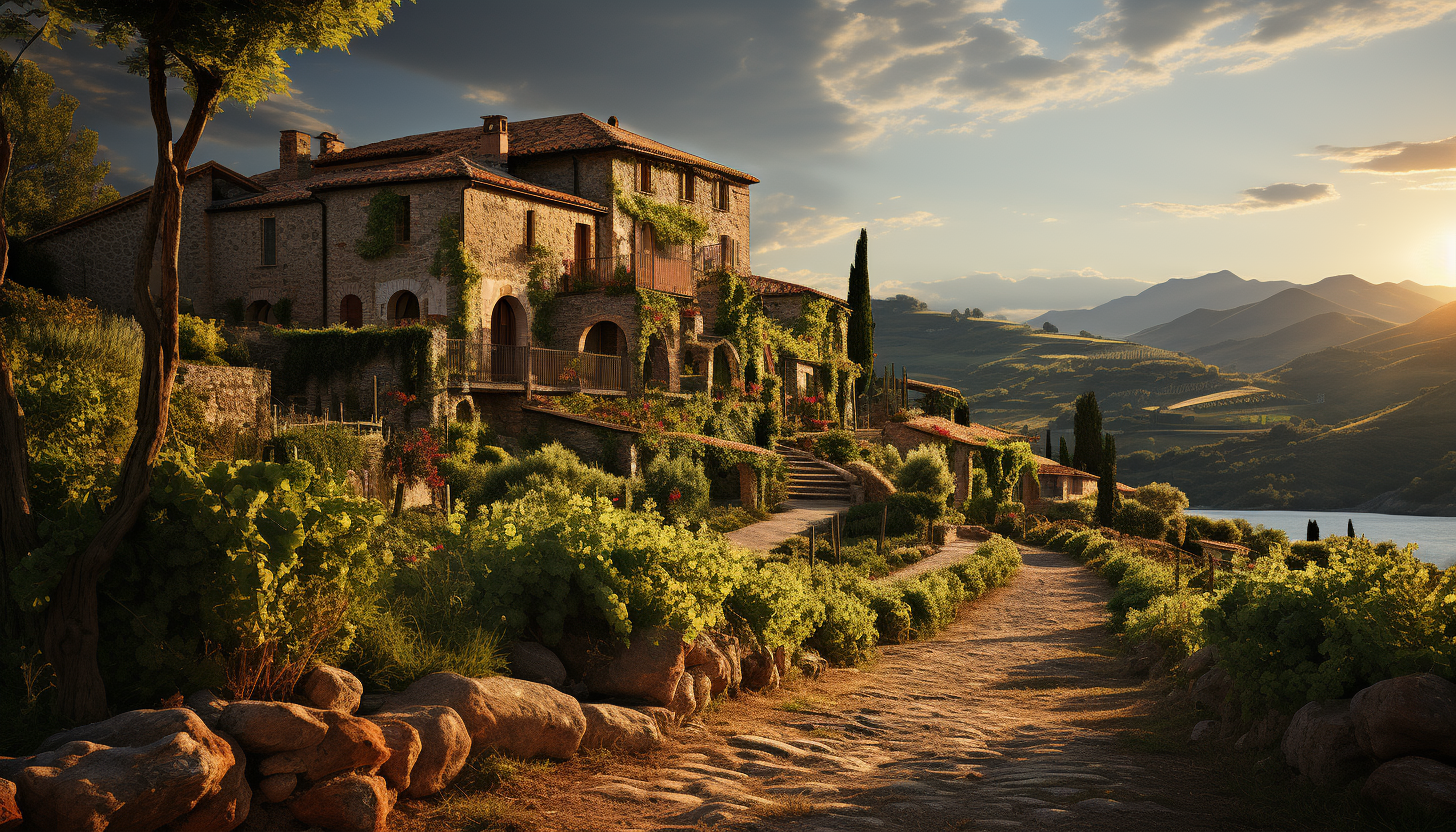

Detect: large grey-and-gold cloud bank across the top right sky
814,0,1456,144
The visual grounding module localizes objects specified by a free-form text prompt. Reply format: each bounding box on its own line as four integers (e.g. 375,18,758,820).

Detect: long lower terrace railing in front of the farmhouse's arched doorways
446,338,628,391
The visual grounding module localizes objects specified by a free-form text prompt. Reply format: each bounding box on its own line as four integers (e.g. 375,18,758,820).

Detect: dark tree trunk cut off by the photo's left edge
0,91,38,638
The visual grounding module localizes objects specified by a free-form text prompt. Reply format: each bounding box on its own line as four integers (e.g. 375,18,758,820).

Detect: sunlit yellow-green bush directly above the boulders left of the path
467,487,748,644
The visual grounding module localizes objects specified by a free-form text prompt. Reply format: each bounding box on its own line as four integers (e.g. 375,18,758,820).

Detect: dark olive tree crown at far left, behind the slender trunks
0,51,119,238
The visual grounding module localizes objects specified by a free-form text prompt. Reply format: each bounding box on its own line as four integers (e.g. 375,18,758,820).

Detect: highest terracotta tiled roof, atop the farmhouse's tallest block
314,112,759,184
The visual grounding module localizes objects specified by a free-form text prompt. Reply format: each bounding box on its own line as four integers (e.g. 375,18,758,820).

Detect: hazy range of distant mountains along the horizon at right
1026,271,1456,339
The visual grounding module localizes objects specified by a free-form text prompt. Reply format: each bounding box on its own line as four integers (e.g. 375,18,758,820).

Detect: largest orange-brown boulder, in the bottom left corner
16,731,233,832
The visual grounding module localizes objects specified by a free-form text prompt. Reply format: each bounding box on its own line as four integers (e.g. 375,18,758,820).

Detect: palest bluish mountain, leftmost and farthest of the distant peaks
1026,270,1292,338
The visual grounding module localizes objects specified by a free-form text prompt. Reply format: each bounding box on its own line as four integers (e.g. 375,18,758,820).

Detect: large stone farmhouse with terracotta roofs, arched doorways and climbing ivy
28,114,853,434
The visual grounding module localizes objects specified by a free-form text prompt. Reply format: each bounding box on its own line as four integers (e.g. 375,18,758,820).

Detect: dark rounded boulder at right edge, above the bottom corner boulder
1350,673,1456,759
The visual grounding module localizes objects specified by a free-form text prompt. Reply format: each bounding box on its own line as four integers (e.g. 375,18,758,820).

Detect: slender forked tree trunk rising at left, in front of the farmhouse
44,42,221,723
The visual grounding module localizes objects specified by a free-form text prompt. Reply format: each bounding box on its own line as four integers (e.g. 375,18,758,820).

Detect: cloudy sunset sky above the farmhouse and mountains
12,0,1456,319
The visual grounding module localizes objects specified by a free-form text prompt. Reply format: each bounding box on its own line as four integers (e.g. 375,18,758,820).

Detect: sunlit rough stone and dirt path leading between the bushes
436,548,1281,832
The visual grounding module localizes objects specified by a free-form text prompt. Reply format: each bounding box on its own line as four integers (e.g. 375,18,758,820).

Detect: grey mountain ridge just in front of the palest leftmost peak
1131,287,1363,355
